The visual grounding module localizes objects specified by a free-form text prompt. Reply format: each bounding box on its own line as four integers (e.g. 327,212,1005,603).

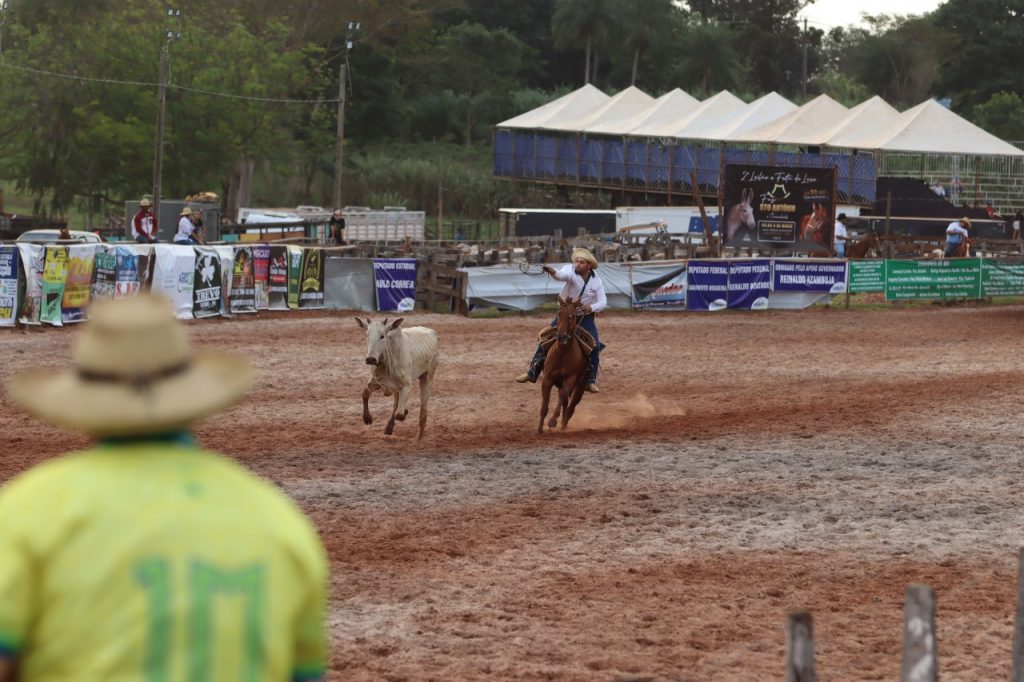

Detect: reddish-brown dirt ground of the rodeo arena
0,305,1024,681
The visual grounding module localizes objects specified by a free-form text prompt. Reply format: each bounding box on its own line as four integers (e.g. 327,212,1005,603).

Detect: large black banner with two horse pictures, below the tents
720,164,836,251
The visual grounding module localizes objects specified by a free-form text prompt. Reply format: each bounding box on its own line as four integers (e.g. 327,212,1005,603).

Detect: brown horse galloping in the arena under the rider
537,297,587,433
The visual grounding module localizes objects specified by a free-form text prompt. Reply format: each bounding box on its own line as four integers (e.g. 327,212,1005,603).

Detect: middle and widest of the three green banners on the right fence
886,258,982,301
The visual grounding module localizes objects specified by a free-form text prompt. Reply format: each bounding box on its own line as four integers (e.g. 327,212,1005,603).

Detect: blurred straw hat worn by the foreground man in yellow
7,294,253,436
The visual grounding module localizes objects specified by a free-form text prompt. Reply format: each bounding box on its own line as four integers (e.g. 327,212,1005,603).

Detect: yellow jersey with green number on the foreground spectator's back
0,438,328,682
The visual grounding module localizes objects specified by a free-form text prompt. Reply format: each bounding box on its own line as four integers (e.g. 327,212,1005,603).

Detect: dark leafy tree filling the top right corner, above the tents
932,0,1024,111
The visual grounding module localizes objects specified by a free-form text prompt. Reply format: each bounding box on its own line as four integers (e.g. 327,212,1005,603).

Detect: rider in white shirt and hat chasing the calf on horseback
516,249,608,393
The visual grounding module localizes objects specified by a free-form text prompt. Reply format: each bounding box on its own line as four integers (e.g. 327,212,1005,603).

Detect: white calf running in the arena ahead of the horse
355,317,437,438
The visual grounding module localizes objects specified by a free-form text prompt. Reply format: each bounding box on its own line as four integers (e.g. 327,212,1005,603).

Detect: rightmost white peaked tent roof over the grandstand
829,99,1024,157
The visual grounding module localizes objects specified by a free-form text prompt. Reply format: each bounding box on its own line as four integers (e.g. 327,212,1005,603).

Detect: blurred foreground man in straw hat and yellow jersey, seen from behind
0,294,328,681
